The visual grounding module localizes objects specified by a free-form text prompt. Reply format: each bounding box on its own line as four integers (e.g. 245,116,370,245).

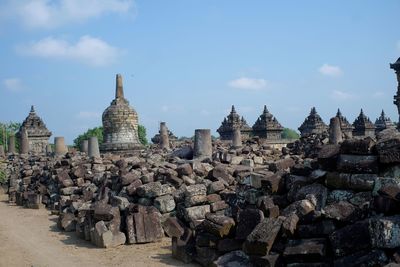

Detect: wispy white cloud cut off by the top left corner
0,0,136,28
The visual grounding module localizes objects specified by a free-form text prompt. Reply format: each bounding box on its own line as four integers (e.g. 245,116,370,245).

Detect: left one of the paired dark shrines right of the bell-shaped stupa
217,105,252,140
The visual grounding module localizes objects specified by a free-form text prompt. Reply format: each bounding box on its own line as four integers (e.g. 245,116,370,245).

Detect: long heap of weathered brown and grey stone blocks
3,130,400,266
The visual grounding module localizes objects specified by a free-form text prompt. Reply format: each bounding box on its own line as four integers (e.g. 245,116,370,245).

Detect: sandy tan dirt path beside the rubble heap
0,195,194,267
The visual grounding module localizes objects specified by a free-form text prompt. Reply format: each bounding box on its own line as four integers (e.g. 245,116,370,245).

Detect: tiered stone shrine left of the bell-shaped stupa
17,106,52,153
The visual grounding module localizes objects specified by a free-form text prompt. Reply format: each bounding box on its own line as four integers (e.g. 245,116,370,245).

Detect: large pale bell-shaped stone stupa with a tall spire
100,74,141,152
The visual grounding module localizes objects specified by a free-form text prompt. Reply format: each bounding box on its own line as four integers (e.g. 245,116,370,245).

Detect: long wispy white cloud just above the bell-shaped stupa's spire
17,35,121,66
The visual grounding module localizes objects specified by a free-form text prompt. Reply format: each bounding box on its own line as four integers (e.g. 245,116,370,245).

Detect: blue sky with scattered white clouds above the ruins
0,0,400,144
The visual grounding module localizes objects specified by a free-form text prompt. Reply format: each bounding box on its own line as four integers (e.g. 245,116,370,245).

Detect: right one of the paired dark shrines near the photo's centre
253,106,283,140
